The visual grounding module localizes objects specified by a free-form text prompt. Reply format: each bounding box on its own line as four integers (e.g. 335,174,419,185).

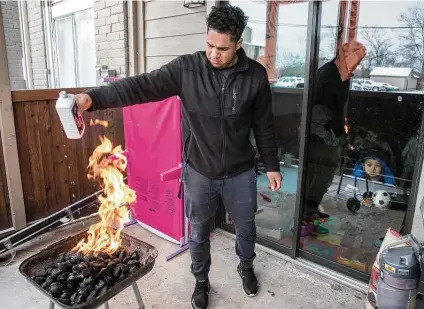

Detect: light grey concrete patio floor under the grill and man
0,220,365,309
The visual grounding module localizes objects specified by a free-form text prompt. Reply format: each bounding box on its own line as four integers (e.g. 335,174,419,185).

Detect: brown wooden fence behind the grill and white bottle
0,88,124,225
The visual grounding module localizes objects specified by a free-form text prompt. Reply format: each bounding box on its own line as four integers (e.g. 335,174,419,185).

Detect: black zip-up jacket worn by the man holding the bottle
87,49,280,179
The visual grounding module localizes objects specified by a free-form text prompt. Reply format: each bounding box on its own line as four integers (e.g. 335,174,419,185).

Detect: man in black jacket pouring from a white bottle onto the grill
77,6,282,309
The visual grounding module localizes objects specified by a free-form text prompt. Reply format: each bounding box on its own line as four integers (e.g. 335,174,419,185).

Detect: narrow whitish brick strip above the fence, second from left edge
27,1,48,89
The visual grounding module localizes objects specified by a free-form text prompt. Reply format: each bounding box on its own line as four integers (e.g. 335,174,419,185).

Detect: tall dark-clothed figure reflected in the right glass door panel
303,40,366,226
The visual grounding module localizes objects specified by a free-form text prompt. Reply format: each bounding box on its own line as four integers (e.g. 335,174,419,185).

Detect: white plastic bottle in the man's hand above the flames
56,91,85,139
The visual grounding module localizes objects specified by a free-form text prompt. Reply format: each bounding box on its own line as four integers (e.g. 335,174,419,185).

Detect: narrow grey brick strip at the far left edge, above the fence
0,1,26,90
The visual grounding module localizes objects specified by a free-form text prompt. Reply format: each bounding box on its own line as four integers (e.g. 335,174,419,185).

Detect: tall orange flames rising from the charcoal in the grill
73,136,136,254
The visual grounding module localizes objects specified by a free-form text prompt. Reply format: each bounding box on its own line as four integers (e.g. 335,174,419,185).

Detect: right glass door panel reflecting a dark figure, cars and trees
300,1,424,273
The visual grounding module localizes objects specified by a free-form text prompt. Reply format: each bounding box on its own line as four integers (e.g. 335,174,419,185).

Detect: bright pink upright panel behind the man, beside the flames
123,97,184,243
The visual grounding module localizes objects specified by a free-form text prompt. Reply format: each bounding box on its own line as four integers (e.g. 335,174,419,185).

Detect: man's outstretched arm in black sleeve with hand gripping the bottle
76,58,181,112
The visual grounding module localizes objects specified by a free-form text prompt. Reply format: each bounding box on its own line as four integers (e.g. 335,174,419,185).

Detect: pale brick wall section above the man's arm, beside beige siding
94,0,128,77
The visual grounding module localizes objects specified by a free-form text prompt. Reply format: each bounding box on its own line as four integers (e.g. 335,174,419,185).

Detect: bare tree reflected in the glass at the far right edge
399,6,424,74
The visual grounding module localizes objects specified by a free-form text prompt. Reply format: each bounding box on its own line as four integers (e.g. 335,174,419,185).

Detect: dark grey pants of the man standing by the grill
183,166,257,280
